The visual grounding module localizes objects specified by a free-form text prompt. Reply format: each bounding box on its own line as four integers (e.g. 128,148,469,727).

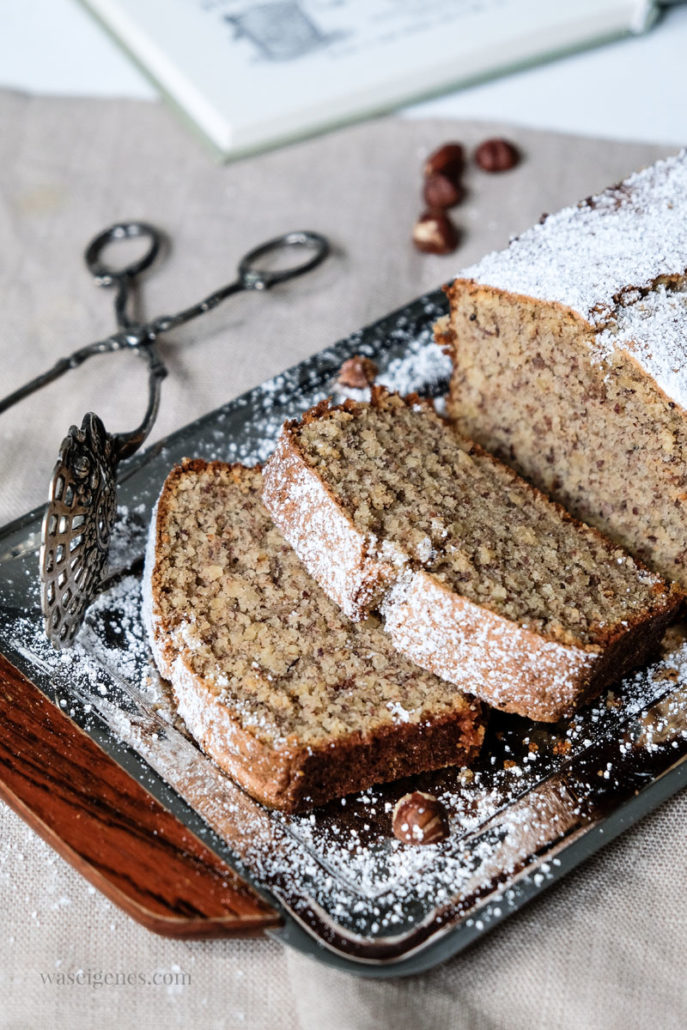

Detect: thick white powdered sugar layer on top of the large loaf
458,150,687,409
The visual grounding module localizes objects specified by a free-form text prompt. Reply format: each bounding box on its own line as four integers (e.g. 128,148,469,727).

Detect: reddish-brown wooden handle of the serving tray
0,655,280,938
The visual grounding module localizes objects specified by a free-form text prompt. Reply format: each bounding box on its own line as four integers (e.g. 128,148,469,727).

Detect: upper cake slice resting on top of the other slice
264,387,682,721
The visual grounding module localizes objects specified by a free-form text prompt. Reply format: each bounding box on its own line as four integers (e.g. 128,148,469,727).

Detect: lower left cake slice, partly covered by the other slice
144,460,484,811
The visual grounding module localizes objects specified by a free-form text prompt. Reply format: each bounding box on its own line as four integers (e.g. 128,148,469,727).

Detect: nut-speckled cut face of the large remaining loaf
436,275,687,588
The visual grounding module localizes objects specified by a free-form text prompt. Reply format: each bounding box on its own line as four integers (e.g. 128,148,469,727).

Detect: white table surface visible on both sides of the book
0,0,687,145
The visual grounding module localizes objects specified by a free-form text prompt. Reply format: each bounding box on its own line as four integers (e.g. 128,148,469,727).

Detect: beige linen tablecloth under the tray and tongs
0,94,687,1030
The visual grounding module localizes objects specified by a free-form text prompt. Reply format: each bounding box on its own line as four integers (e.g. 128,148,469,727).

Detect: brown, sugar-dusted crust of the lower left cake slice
143,460,485,812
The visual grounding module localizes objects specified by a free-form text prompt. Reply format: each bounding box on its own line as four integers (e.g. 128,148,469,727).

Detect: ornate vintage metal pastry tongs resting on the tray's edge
0,221,330,648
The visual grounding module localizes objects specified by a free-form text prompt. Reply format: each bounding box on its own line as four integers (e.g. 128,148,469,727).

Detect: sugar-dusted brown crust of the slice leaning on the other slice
265,388,682,722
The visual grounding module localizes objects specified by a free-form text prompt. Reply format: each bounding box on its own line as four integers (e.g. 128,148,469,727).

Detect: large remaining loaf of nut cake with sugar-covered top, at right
437,151,687,586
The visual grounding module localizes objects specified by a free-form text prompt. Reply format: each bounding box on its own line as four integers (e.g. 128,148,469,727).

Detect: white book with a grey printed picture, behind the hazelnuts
76,0,656,158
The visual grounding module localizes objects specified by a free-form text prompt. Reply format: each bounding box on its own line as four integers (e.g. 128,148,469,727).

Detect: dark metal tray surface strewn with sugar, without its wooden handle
0,291,687,976
